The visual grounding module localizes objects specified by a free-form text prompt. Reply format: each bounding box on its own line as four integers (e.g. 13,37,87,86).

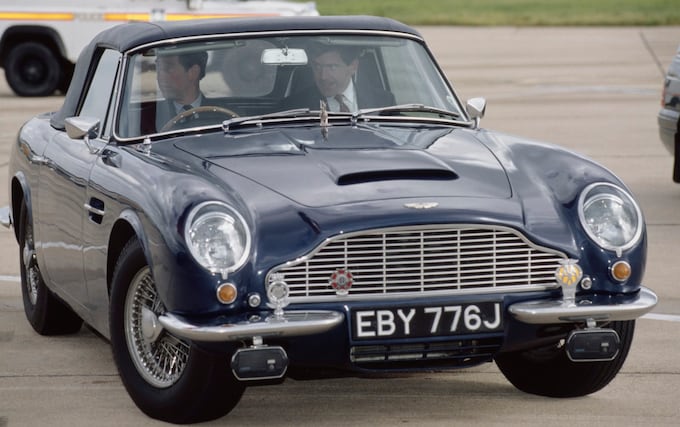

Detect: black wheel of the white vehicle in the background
5,42,63,96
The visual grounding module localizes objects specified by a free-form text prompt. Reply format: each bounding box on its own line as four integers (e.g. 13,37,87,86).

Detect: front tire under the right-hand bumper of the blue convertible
495,320,635,397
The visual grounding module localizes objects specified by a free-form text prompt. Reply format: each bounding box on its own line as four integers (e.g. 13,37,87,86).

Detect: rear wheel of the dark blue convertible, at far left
19,204,83,335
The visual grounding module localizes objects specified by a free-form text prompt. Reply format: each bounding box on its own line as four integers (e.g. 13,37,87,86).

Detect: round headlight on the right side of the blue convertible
578,183,643,253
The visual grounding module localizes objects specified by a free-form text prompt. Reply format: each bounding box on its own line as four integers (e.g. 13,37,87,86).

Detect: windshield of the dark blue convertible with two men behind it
116,34,464,139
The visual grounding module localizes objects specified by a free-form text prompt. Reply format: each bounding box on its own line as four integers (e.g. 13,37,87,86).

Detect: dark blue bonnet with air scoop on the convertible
176,126,512,207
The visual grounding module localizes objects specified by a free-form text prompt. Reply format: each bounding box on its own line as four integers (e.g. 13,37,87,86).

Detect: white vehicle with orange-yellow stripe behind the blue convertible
0,0,319,96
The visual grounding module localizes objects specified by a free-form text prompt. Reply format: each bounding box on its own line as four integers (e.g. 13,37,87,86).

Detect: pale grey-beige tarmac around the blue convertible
0,27,680,427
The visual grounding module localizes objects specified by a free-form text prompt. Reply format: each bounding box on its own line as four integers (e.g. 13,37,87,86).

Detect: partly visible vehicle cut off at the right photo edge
658,43,680,183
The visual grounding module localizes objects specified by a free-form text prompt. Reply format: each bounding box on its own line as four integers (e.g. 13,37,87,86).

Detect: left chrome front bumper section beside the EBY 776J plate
158,311,345,342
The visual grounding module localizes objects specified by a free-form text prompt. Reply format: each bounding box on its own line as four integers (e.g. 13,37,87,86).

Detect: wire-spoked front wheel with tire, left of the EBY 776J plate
110,239,244,424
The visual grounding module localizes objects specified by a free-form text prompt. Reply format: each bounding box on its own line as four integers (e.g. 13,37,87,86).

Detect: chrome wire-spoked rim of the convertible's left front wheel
125,267,189,388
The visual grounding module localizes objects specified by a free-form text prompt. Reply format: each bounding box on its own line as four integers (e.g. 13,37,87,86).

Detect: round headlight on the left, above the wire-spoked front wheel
184,202,250,276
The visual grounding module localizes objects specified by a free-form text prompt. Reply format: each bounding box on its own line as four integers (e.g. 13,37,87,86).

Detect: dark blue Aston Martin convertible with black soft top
4,17,657,423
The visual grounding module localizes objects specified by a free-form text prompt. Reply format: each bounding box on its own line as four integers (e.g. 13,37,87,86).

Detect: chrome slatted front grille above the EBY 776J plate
267,225,566,302
